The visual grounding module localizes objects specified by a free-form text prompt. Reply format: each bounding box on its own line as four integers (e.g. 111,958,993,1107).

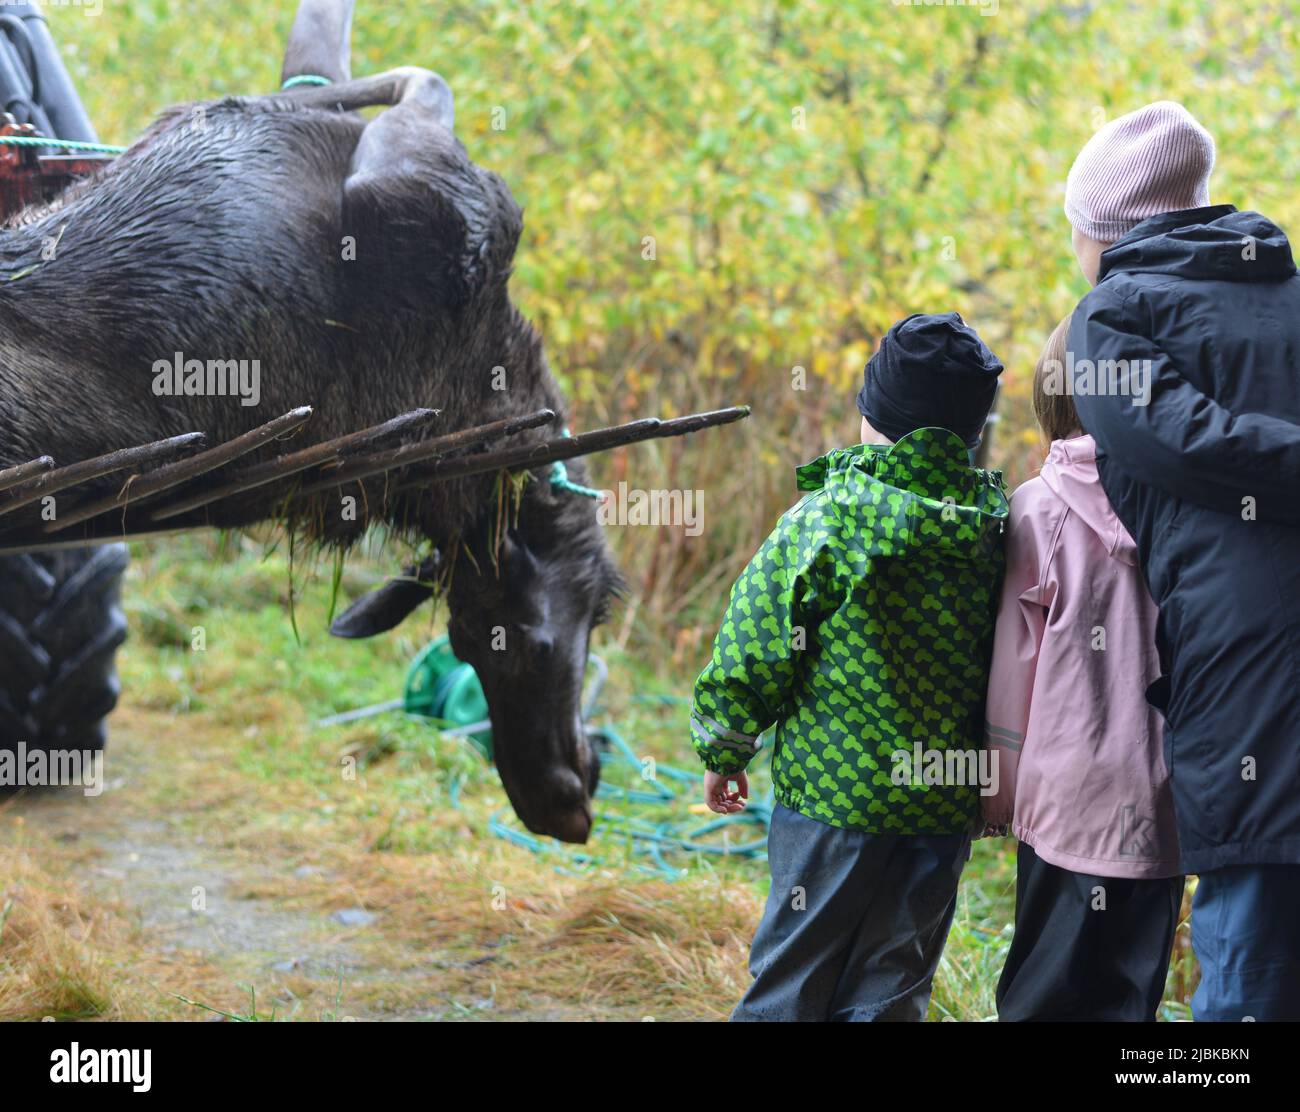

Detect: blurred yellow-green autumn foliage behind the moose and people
61,0,1300,655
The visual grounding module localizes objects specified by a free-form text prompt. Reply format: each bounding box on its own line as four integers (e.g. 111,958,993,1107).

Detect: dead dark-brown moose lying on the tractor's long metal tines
0,0,748,841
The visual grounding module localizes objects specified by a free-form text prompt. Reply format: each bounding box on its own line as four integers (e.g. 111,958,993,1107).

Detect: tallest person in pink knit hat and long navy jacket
1066,101,1300,1020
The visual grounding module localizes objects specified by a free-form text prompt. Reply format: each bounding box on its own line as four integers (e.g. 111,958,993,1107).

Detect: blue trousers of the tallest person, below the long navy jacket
1192,865,1300,1024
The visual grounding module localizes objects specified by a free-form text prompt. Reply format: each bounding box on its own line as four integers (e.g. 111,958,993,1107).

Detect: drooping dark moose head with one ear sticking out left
333,452,620,841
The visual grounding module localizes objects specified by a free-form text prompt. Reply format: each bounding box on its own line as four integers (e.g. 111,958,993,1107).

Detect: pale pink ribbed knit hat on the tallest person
1065,100,1214,243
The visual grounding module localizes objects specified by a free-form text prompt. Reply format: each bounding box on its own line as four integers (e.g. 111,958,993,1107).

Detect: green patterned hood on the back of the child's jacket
797,428,1008,559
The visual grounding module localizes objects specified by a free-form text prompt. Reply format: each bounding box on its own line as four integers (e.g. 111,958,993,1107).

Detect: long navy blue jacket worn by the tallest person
1069,205,1300,873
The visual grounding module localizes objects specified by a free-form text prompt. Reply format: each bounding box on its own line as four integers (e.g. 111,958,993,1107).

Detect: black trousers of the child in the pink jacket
997,841,1183,1022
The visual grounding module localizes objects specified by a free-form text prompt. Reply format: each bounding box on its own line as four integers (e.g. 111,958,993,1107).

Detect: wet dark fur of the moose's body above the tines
0,99,574,541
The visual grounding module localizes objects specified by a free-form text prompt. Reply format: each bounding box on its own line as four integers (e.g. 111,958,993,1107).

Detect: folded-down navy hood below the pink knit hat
1097,204,1296,285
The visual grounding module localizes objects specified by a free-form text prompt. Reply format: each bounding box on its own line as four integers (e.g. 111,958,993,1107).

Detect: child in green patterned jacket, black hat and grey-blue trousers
692,313,1008,1020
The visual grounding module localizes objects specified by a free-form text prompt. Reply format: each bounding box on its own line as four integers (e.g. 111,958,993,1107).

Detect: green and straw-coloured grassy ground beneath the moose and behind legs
0,536,1193,1021
